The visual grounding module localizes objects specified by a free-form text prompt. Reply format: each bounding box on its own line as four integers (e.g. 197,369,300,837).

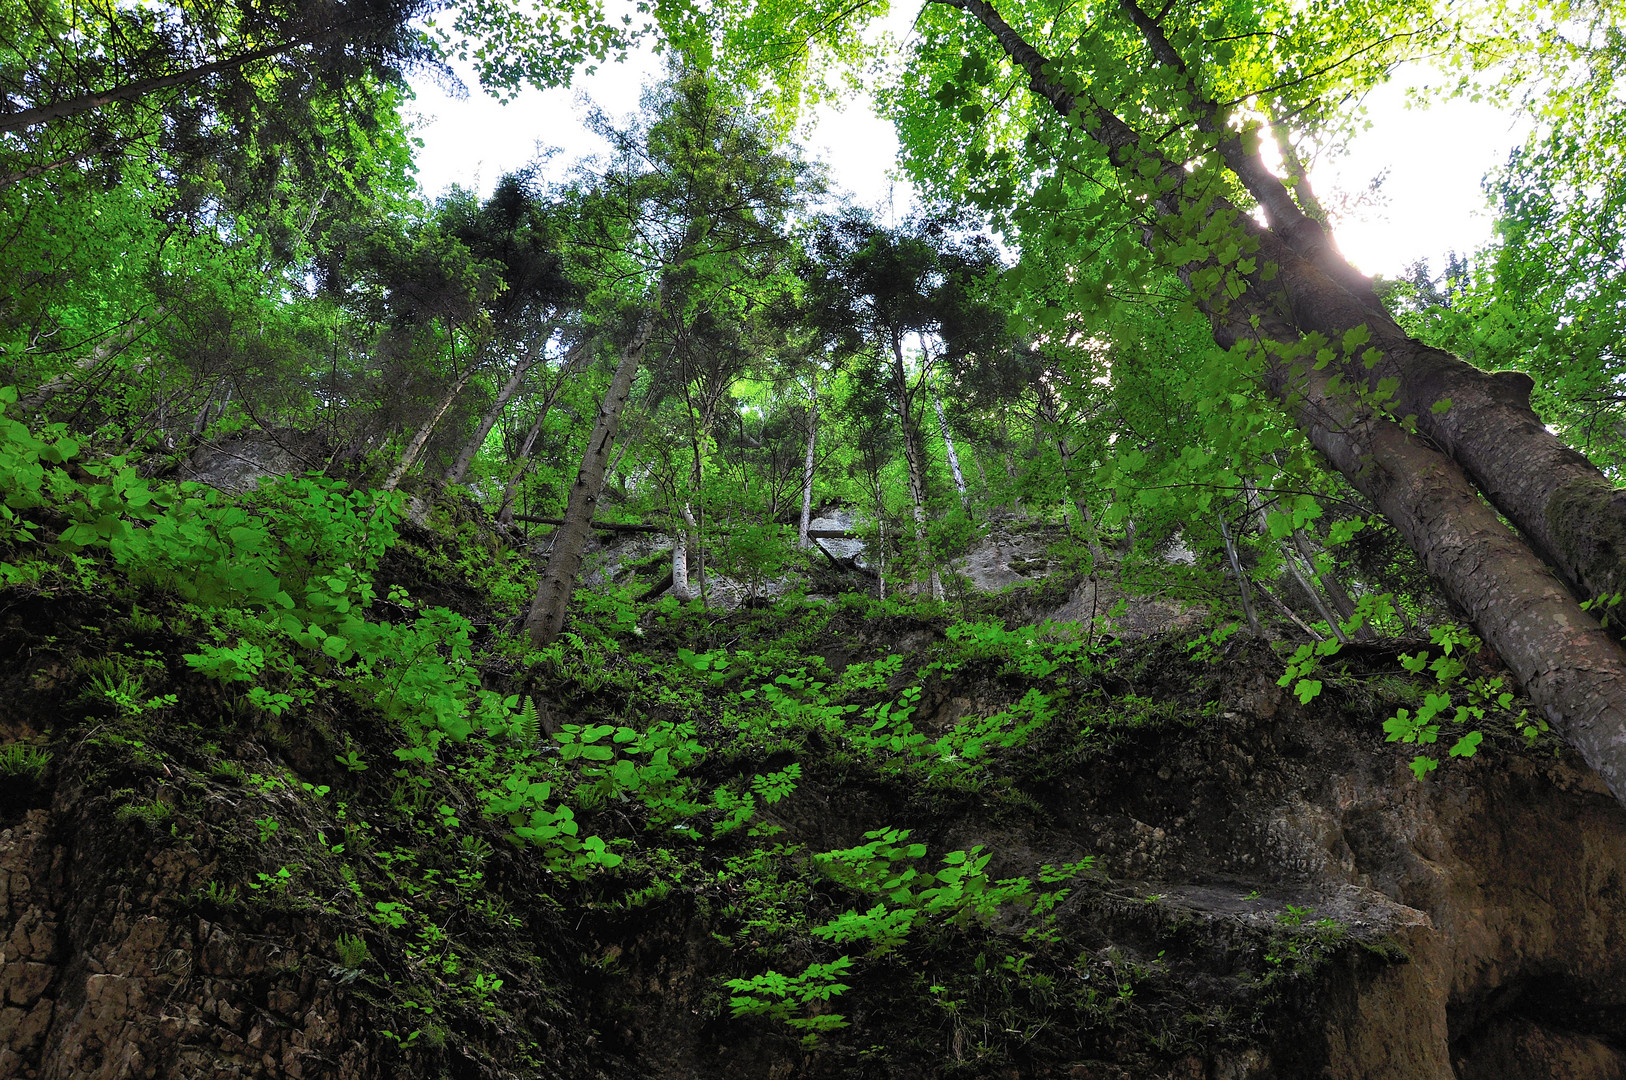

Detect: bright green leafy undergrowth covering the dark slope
0,406,1547,1077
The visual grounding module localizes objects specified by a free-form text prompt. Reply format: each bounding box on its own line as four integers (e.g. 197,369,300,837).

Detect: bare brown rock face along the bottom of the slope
0,598,1626,1080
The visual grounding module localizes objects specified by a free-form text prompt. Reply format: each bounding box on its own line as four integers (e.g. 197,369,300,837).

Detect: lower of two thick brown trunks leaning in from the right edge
940,0,1626,803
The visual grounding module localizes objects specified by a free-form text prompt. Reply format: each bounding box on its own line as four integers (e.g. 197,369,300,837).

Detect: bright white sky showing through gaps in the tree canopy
411,27,1528,277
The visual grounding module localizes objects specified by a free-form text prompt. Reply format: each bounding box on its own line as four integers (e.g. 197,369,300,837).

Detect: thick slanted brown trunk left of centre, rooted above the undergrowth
525,313,665,649
